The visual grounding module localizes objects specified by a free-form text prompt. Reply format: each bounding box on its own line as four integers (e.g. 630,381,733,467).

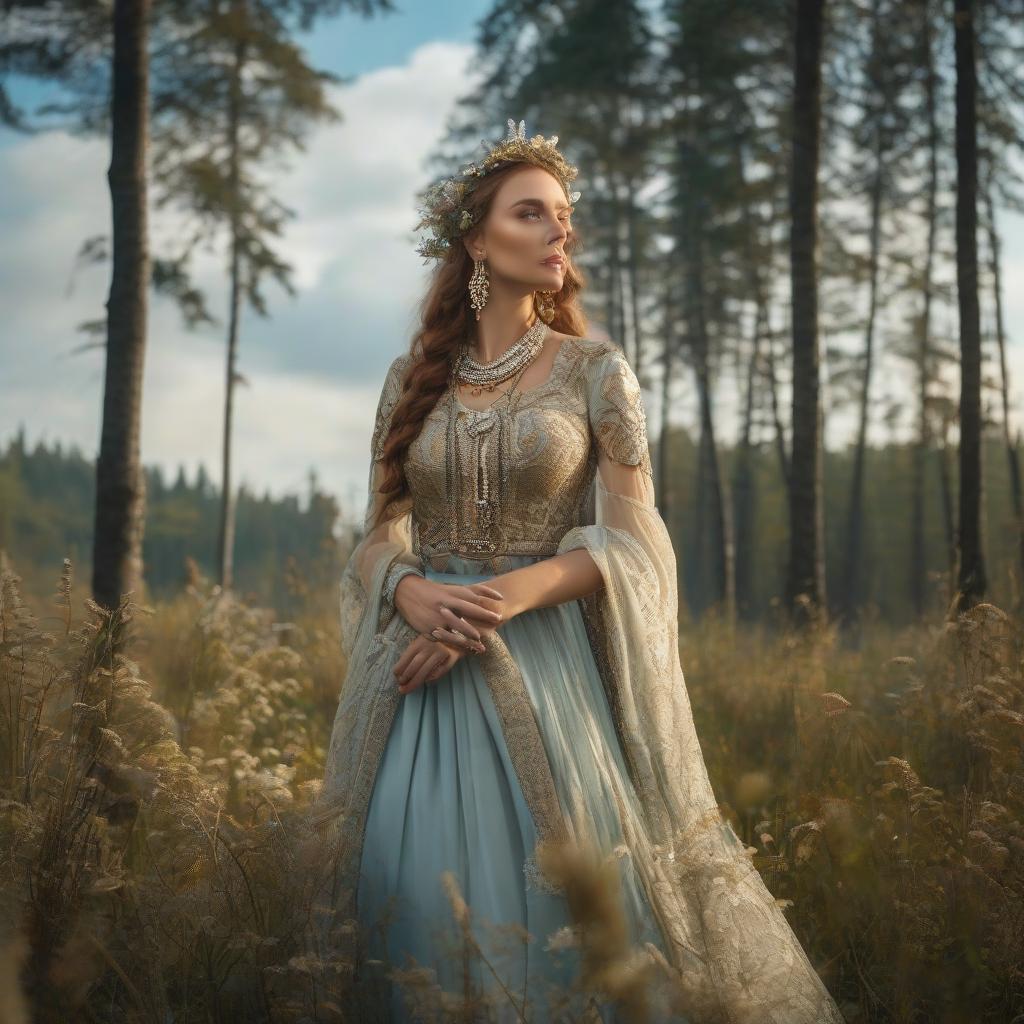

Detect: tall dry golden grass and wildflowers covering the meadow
0,553,1024,1024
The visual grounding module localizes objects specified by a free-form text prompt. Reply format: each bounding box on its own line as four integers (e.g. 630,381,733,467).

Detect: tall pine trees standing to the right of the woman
425,0,1024,622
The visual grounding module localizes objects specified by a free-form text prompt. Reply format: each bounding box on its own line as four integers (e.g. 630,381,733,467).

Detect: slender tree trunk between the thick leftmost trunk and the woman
217,9,246,591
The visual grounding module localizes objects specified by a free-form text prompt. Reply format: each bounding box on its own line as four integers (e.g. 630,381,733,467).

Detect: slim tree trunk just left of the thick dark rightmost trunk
907,0,939,618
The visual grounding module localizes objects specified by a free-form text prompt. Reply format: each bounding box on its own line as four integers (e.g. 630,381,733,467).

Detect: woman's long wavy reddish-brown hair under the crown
373,161,587,525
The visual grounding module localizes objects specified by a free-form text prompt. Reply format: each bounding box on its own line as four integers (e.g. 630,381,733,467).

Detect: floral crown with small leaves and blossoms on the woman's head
413,118,580,262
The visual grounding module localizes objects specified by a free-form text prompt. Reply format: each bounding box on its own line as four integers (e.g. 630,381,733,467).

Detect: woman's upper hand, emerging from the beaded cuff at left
394,572,505,653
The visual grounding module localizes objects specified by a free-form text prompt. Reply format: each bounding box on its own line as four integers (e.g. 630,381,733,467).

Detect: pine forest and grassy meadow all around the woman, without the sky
0,0,1024,1024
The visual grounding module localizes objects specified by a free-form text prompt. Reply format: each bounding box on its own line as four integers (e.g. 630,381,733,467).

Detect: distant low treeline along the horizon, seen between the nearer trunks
0,419,1016,625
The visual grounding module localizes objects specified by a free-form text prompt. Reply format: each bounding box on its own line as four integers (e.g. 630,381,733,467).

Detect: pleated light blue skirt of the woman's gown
356,556,683,1022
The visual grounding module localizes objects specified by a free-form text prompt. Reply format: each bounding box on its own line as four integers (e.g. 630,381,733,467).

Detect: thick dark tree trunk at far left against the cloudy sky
92,0,150,608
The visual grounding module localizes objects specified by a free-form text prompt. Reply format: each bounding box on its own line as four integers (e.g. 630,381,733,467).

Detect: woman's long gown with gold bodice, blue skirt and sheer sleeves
316,337,843,1024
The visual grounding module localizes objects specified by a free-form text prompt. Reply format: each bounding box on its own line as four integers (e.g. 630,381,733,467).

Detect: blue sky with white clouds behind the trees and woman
0,0,1024,515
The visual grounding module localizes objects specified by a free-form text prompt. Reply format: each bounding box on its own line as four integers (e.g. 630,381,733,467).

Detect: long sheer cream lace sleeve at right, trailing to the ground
558,348,843,1024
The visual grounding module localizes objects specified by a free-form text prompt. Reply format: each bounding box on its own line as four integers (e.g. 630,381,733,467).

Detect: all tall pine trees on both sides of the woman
0,0,1024,622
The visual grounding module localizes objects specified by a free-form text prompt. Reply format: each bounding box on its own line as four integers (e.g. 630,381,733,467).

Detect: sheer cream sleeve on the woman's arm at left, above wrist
340,355,420,660
